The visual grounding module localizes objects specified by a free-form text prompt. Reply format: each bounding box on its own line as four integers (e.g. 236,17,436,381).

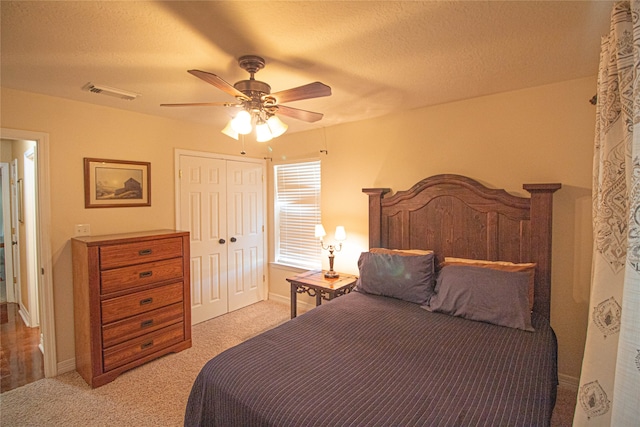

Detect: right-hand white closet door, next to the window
227,161,264,311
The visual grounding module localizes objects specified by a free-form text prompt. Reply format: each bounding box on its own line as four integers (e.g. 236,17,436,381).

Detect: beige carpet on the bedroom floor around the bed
0,301,575,427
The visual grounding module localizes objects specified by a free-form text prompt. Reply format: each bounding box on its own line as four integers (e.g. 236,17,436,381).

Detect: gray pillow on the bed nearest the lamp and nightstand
356,252,435,304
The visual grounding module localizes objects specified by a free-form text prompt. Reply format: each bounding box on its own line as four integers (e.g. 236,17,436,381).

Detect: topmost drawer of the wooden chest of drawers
100,237,182,270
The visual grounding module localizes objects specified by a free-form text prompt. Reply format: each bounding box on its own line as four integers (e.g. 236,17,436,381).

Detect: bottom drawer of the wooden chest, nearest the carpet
103,322,184,372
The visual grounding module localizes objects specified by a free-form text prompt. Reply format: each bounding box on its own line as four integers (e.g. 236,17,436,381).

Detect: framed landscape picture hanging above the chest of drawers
84,157,151,208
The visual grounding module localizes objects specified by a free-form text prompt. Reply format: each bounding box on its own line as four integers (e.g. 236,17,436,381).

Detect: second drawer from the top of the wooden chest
100,258,183,294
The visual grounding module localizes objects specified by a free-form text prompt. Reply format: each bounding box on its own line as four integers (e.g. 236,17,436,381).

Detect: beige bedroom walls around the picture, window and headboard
1,77,595,379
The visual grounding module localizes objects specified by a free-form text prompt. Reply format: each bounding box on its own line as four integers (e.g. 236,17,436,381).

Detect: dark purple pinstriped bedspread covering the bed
184,292,557,427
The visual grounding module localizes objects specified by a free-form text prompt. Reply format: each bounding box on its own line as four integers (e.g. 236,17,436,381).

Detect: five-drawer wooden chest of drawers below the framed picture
71,230,191,387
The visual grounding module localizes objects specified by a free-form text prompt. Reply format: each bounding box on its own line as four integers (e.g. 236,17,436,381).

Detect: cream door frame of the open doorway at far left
0,128,58,378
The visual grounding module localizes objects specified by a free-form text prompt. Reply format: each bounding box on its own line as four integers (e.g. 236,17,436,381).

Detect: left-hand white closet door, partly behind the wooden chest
180,155,228,324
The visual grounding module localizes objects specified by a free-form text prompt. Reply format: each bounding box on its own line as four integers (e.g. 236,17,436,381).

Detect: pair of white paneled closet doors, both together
179,154,265,324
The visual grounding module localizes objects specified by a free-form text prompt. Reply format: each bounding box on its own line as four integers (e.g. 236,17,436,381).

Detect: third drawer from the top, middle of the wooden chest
101,282,184,324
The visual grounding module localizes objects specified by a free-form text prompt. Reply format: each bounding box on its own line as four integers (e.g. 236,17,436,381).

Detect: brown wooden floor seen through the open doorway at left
0,303,44,393
